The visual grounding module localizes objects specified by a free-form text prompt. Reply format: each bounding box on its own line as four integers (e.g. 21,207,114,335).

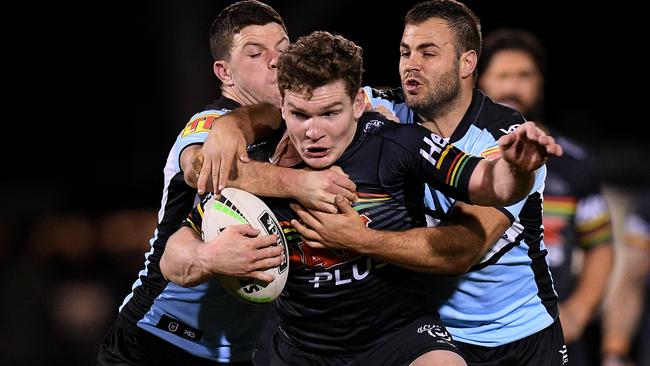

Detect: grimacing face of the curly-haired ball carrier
282,80,364,169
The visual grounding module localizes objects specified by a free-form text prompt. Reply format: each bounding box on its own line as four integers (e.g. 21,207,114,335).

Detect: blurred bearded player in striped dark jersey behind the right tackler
479,29,613,365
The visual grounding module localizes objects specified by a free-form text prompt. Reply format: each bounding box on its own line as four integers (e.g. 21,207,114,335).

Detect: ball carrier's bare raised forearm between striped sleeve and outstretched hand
469,159,535,206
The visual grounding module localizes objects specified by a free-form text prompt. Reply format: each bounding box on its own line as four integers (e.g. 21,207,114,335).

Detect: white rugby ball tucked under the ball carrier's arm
201,188,289,304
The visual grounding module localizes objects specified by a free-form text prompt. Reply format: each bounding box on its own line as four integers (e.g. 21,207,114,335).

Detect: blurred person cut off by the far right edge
603,191,650,366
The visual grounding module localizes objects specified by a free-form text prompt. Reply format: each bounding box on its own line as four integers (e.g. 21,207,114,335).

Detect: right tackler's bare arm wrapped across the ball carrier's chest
292,197,510,274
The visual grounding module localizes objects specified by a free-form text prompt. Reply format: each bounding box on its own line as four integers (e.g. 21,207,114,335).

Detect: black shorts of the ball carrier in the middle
271,315,460,366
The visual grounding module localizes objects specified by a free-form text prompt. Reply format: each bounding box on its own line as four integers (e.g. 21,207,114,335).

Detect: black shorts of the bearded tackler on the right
456,319,569,366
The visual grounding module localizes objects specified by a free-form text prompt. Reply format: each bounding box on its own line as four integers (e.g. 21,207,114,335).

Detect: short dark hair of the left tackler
210,0,287,61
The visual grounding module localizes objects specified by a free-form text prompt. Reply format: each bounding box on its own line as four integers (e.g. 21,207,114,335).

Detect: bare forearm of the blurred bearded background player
565,245,613,322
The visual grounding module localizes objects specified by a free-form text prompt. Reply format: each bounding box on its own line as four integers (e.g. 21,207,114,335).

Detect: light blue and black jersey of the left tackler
120,98,270,363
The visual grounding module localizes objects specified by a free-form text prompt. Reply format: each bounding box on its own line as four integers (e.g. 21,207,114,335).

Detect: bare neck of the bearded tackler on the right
418,87,474,138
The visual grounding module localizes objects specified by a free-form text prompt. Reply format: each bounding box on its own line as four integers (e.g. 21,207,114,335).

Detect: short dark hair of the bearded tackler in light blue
404,0,481,56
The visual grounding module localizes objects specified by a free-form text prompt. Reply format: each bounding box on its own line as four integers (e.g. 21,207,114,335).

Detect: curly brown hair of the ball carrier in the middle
278,32,363,99
